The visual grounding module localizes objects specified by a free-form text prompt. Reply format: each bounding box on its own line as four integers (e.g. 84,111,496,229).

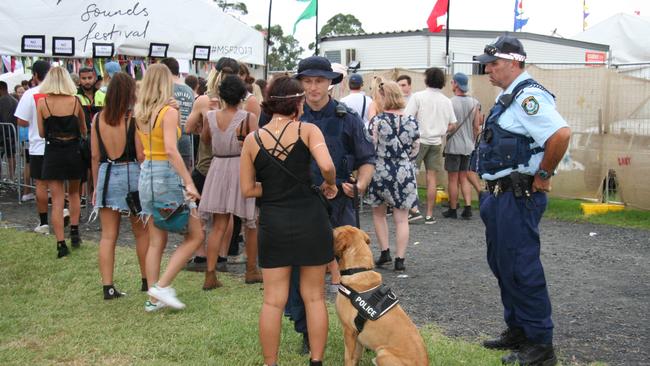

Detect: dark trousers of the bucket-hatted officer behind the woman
284,195,356,333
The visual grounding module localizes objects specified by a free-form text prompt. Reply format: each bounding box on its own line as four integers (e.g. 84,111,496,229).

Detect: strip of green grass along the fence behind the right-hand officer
418,188,650,230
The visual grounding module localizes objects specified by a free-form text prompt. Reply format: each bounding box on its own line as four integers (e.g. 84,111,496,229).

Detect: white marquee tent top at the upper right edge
573,13,650,64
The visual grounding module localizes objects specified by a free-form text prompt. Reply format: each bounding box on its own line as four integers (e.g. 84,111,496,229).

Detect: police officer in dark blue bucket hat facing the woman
287,56,375,352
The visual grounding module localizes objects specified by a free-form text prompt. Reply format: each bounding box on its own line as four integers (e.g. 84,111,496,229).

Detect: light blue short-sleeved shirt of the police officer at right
481,71,568,180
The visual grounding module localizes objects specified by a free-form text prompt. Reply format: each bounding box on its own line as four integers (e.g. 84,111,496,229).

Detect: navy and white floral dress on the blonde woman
368,112,420,209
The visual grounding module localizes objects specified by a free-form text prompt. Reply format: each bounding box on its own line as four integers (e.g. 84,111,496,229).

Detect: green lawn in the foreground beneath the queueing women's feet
0,229,516,365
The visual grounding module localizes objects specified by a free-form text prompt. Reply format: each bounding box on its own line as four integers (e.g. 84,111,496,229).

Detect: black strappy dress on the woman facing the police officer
254,124,334,268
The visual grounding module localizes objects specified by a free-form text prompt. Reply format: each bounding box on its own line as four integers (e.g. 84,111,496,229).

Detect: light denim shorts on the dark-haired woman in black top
93,162,140,213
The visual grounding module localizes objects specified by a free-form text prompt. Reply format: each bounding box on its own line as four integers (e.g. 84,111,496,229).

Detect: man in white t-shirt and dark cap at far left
14,60,50,234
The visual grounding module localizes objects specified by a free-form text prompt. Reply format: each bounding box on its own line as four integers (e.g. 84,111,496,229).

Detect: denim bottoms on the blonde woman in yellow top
138,160,196,219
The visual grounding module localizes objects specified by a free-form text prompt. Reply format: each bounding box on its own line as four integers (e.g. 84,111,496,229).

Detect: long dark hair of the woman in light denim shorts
102,72,135,126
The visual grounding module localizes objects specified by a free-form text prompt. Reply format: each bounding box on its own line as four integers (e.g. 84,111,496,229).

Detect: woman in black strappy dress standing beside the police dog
241,76,338,365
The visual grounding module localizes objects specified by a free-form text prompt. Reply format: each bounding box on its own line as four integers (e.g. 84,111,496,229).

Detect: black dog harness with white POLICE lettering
339,283,399,333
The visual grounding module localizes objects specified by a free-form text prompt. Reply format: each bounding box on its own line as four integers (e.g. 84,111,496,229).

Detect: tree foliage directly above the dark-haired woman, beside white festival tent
255,24,305,71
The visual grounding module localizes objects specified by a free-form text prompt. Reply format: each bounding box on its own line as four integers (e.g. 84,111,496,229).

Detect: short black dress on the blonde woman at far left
41,97,85,180
